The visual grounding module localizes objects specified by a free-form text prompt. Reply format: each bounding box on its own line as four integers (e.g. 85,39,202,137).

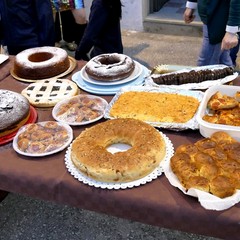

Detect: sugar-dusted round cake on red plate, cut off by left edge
0,89,30,137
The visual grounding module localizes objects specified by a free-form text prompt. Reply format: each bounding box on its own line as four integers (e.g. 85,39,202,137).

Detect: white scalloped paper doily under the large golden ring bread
65,132,174,190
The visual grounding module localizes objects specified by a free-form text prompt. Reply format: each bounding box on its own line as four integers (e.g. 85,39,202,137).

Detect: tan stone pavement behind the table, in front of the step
122,31,202,67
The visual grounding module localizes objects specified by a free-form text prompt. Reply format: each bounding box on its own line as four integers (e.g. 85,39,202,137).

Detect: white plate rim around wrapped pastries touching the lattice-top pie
52,94,108,126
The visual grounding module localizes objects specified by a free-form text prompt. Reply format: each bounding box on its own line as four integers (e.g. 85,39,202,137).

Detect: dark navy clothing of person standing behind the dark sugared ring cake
75,0,123,60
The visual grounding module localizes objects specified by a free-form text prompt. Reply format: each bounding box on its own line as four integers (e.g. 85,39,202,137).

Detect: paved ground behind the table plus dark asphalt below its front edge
0,31,221,240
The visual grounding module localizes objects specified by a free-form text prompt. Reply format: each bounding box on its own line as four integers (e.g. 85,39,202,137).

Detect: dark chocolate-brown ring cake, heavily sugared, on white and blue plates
85,53,135,81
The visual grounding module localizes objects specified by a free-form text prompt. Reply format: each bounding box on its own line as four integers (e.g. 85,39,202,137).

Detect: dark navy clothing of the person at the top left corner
0,0,55,55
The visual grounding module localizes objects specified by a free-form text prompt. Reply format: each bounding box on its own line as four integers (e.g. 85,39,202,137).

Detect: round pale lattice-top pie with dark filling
21,79,78,107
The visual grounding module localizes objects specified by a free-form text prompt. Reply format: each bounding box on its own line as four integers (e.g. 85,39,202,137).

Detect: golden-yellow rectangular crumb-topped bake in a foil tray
110,91,199,123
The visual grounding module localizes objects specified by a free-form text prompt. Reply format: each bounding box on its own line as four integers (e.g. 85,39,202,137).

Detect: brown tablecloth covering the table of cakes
0,57,240,239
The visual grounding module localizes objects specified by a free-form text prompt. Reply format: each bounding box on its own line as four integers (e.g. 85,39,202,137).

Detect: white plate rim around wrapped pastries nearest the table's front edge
13,121,73,157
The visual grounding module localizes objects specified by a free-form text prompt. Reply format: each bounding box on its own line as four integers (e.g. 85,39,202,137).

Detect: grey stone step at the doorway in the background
143,16,202,37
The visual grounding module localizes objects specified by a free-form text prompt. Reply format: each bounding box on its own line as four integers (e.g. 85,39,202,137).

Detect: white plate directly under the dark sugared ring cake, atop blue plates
80,61,143,86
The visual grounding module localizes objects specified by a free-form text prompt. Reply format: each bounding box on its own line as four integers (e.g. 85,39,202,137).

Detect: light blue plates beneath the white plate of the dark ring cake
72,65,149,95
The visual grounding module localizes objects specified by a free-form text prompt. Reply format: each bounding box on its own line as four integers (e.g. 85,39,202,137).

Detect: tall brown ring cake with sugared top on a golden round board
13,47,70,80
